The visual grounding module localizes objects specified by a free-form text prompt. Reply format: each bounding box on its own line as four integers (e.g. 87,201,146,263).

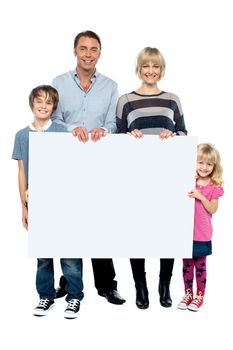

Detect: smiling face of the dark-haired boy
33,92,53,121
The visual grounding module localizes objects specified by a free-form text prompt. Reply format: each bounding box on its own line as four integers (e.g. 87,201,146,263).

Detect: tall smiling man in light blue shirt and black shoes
52,31,125,305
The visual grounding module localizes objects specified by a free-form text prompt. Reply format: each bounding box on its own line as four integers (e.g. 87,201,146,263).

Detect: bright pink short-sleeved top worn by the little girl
193,182,224,241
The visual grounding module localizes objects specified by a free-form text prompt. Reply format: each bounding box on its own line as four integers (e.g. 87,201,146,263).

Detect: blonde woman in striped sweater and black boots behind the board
117,47,187,309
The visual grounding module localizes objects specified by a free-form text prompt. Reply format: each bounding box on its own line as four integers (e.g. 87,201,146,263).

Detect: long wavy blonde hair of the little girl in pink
197,143,223,186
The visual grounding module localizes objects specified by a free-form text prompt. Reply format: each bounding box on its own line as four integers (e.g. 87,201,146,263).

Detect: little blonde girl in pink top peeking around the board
178,143,224,311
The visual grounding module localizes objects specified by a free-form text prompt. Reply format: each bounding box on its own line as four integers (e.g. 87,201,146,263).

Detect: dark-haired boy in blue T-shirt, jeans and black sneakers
12,85,84,318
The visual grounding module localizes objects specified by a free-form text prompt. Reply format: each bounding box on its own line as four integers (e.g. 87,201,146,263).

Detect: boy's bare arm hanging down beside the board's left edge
18,160,28,230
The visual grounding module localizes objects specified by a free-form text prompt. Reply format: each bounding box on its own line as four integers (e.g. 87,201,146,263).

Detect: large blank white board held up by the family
29,132,197,258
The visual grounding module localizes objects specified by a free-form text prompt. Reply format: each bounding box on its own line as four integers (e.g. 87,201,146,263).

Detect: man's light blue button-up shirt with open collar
52,70,118,133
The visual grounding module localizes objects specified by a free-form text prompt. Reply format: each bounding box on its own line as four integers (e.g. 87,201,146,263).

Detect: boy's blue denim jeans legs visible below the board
36,258,84,302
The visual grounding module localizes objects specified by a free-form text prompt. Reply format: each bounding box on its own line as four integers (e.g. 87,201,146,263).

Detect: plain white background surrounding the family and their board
0,0,233,350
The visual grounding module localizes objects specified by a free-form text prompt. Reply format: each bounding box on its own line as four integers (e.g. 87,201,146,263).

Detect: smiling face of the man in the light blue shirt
74,37,100,72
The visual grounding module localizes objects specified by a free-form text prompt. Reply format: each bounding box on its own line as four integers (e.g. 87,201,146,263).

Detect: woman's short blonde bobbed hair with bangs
135,47,166,79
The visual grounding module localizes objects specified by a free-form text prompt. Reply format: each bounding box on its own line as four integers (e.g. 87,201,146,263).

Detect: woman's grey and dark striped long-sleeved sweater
116,91,187,135
